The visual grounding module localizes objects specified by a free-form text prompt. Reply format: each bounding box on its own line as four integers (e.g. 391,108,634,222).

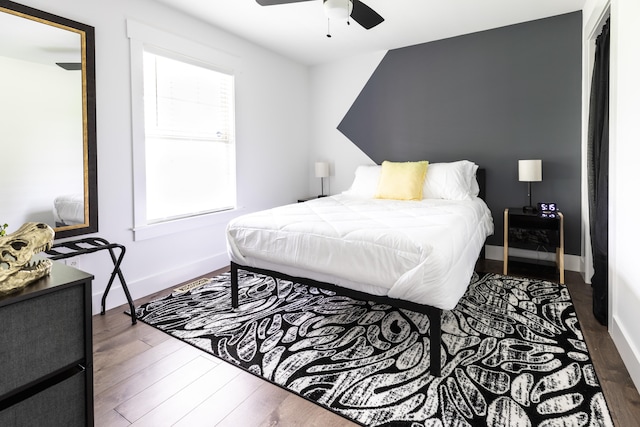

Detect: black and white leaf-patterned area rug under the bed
136,271,613,427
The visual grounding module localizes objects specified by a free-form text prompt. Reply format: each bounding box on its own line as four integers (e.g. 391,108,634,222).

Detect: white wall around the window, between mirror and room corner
11,0,309,312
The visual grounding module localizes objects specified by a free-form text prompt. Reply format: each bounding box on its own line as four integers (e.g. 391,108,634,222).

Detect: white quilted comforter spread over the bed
227,194,493,310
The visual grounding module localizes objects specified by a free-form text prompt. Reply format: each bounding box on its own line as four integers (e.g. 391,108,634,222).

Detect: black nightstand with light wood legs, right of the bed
503,208,564,284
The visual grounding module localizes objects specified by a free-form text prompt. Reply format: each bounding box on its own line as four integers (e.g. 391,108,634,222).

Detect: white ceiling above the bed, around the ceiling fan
150,0,585,65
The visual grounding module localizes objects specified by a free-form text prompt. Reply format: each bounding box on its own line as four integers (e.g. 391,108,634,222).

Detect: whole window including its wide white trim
127,20,242,240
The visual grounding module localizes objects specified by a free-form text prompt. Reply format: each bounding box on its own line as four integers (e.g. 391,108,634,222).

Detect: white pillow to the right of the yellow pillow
422,160,480,200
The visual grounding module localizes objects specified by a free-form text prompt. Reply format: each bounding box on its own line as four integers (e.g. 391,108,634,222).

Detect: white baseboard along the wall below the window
91,252,229,314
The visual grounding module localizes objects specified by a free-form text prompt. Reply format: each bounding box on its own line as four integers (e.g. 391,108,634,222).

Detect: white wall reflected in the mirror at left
0,56,83,227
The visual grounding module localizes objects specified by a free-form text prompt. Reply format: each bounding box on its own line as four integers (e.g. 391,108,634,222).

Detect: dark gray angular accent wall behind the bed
338,12,582,255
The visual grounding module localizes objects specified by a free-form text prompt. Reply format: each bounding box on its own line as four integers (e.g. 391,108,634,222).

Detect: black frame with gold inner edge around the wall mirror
0,0,98,239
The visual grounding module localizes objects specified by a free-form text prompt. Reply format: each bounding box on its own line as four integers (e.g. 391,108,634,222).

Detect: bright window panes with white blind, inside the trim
143,50,235,224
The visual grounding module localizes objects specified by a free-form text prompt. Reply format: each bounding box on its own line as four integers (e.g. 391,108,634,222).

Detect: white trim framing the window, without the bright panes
127,20,240,241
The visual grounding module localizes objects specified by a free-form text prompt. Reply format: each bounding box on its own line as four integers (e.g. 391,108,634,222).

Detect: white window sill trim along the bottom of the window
133,208,245,241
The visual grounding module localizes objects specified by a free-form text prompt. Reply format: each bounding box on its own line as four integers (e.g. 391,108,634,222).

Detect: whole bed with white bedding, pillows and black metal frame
227,160,493,376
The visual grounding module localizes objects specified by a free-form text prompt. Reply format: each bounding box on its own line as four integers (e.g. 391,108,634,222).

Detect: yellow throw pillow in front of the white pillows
375,160,429,200
